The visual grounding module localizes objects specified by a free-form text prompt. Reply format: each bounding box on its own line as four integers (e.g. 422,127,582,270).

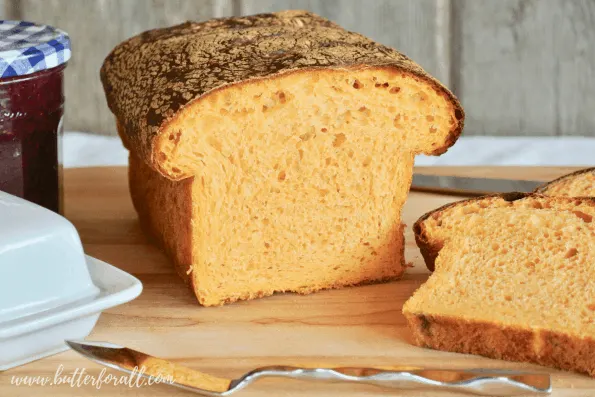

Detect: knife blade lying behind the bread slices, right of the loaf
411,174,545,196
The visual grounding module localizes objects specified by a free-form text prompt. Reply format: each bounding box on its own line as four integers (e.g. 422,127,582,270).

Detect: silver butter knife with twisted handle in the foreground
66,340,552,397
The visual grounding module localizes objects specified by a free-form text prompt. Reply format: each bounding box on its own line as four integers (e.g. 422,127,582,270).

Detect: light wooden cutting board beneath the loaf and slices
0,167,595,397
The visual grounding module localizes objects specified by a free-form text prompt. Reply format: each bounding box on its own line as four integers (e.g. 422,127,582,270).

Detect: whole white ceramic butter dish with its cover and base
0,192,142,371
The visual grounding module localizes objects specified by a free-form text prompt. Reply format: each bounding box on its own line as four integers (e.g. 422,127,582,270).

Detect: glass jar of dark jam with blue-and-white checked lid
0,21,70,212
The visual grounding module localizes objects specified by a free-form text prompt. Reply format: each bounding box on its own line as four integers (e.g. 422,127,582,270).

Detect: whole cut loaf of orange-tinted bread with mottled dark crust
101,11,464,306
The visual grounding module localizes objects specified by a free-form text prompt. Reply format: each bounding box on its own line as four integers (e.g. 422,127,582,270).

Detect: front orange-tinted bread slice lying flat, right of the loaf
403,193,595,376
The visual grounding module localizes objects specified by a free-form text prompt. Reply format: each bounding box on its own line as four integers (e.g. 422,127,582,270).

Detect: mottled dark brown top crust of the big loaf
101,11,464,173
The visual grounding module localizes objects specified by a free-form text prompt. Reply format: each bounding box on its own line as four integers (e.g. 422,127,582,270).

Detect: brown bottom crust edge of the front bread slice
405,314,595,376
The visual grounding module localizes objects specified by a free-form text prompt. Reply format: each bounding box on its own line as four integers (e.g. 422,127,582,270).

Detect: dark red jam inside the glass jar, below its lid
0,65,66,212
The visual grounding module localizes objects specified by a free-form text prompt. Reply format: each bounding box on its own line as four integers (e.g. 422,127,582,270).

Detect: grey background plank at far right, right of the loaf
452,0,595,136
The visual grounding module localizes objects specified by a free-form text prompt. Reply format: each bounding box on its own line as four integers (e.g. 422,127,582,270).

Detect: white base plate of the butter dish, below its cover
0,256,142,371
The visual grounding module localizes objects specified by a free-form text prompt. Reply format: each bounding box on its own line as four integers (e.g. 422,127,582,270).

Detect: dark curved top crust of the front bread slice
413,192,533,271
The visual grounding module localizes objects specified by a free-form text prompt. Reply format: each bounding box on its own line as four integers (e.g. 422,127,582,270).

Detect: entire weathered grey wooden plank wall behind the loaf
0,0,595,136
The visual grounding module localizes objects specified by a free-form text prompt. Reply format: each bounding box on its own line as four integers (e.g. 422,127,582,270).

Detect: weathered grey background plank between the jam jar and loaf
15,0,233,135
